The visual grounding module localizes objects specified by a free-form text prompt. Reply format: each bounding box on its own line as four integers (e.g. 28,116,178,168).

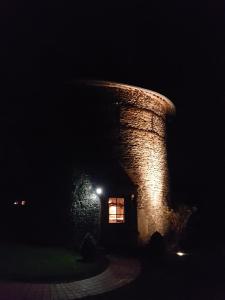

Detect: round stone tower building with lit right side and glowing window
68,81,175,245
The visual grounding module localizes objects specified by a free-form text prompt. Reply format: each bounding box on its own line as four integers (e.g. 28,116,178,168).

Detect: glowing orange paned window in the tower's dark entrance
108,198,125,223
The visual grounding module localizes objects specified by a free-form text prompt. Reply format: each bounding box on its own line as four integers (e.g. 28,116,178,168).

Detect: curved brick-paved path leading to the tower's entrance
0,256,141,300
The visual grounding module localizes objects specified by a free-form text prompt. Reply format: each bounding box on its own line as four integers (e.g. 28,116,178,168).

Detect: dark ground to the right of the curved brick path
91,246,225,300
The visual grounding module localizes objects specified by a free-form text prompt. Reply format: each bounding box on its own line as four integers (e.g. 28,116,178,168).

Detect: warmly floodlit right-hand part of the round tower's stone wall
81,81,175,243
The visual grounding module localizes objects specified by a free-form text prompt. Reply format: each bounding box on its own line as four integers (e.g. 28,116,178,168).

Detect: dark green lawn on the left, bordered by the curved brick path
0,244,107,282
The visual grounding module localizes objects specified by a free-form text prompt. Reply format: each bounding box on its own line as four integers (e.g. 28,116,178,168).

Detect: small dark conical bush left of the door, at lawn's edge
80,232,97,261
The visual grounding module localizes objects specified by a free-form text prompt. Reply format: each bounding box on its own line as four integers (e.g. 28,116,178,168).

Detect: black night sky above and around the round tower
0,0,225,237
